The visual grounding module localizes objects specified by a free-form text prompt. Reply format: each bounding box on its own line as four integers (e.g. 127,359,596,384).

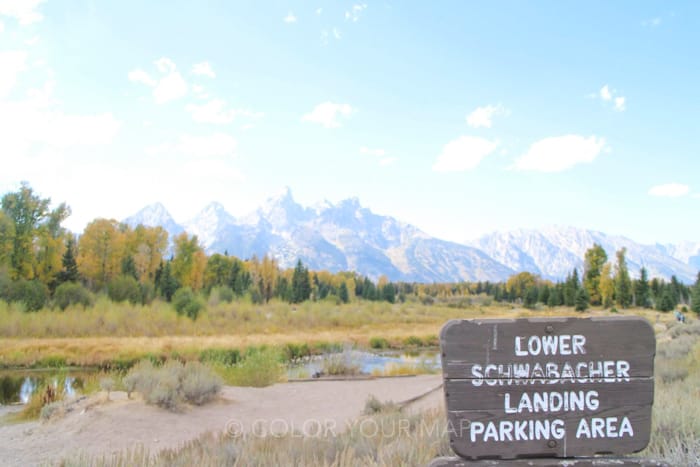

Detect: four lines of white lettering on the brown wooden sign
456,328,634,443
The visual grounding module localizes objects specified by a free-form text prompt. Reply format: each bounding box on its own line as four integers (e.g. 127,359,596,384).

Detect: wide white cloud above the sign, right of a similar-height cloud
514,135,605,172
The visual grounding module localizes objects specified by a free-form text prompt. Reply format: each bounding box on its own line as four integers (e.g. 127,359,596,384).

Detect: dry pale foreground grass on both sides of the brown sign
58,320,700,467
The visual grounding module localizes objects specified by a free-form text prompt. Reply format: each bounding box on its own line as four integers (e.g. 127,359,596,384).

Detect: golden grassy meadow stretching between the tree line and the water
0,300,674,368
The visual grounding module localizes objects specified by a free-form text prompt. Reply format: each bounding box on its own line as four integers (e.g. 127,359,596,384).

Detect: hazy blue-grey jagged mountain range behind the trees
124,189,700,283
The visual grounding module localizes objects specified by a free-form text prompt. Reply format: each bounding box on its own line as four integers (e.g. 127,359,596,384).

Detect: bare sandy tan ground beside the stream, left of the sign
0,375,444,466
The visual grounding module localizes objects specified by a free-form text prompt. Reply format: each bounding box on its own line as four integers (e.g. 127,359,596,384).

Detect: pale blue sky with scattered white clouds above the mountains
0,0,700,243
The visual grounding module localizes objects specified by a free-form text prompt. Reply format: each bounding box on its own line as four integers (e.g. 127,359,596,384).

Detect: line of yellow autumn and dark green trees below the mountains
0,183,700,318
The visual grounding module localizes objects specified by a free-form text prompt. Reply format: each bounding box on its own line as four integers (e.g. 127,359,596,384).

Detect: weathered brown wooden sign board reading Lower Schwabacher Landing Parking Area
440,316,656,459
